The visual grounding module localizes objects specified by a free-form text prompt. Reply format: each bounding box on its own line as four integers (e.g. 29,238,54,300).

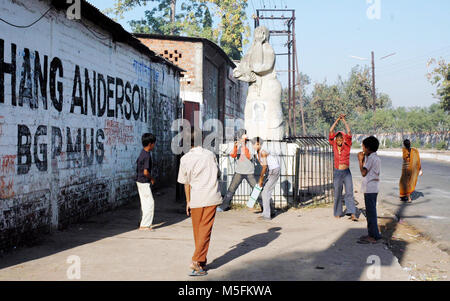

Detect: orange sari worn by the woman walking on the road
399,148,421,197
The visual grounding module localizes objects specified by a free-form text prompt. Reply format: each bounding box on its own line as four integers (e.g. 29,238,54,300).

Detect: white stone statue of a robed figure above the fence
233,26,284,140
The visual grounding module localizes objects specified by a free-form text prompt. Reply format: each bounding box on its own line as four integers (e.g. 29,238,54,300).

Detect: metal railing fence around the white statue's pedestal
219,137,333,208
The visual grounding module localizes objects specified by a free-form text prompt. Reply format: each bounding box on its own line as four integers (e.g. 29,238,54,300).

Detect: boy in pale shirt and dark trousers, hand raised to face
358,136,381,244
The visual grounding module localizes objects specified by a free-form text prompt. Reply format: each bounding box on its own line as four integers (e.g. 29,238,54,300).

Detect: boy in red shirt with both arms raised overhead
328,114,358,221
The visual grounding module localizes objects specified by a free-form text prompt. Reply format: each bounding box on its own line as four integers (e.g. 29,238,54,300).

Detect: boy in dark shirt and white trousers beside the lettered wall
136,133,156,231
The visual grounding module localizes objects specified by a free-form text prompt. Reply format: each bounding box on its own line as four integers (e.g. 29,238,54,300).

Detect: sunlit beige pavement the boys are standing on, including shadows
0,189,408,281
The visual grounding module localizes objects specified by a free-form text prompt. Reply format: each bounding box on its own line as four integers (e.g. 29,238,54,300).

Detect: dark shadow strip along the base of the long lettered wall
0,188,188,269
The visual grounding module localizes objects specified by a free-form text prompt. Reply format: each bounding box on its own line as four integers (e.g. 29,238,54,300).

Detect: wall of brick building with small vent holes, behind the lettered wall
139,38,248,135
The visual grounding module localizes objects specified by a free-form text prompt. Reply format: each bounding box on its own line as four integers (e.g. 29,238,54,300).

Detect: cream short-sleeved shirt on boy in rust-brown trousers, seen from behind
178,146,222,208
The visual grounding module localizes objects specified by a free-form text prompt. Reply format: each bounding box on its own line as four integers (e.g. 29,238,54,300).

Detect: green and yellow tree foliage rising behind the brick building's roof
105,0,250,60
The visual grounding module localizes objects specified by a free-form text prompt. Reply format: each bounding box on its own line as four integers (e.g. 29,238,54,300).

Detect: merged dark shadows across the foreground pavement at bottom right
208,228,406,281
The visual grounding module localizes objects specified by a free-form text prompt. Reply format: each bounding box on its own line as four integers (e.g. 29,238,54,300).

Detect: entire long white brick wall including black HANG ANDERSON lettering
0,0,181,249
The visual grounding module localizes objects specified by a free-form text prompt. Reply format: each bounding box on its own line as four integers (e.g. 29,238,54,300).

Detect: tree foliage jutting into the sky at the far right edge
427,58,450,112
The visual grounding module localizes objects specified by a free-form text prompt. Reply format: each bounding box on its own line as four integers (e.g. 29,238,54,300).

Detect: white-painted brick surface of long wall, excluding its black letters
0,0,180,247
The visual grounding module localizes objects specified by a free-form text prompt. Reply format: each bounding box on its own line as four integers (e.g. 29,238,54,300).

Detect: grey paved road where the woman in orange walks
350,154,450,248
